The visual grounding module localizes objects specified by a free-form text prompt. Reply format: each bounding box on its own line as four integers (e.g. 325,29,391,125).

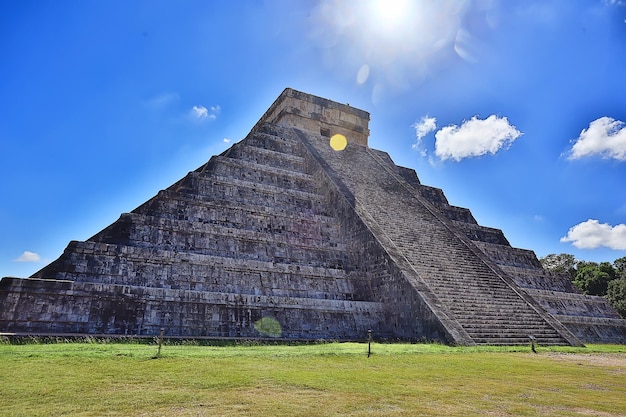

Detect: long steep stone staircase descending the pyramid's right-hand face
300,128,576,345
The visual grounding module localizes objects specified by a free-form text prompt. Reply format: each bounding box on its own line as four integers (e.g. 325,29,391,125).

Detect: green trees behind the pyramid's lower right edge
539,253,626,318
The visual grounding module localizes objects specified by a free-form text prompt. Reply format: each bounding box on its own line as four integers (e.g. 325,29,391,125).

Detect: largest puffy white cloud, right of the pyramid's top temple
435,114,522,161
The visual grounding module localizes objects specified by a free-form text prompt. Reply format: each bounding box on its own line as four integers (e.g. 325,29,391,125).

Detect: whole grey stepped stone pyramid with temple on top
0,89,626,345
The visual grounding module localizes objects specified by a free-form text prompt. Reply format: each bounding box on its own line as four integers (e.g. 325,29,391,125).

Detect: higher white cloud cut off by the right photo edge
569,117,626,161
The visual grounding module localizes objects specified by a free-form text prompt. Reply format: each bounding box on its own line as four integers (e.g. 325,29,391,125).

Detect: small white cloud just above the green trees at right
561,219,626,250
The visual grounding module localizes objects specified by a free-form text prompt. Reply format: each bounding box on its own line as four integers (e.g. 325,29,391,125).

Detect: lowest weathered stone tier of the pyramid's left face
0,278,383,340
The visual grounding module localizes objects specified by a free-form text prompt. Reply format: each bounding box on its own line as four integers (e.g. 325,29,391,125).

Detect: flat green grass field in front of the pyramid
0,343,626,417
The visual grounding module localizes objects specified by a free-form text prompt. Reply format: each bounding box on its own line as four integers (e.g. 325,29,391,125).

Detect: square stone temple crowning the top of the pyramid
253,88,370,146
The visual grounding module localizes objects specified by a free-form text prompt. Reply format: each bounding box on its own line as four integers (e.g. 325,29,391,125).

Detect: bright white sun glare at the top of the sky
311,0,470,99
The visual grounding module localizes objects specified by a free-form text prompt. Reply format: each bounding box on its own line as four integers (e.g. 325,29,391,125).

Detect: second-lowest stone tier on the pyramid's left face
37,241,372,300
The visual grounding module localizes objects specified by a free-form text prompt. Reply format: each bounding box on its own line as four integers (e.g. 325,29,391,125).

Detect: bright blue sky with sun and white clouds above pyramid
0,0,626,276
